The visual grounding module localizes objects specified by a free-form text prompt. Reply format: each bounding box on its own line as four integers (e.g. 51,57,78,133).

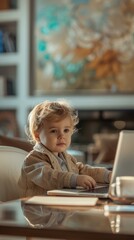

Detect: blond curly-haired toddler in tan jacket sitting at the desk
19,100,111,196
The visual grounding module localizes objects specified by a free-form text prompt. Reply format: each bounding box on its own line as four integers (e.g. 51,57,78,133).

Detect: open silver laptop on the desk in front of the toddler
47,130,134,198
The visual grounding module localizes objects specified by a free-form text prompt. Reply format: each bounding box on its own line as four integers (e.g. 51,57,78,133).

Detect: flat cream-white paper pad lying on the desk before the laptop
26,196,98,206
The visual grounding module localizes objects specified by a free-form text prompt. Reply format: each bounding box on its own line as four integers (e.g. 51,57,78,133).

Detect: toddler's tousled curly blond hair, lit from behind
26,100,79,143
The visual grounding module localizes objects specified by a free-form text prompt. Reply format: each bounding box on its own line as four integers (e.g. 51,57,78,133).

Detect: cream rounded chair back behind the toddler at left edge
0,146,28,201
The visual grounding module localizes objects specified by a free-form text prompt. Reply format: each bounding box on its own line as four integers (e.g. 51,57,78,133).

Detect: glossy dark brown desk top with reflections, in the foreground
0,197,134,240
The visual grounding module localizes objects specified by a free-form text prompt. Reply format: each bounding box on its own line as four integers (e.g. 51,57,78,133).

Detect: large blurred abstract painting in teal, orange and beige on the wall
31,0,134,95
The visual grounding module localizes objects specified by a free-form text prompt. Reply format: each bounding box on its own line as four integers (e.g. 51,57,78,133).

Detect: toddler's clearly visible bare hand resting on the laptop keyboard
76,175,96,189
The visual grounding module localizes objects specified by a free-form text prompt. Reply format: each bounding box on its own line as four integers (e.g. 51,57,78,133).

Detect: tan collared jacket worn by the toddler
18,144,109,197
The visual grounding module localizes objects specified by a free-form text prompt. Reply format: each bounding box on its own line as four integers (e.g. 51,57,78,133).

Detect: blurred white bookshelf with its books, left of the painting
0,0,29,135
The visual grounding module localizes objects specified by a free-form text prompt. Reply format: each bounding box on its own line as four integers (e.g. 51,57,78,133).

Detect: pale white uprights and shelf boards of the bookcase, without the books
0,0,30,136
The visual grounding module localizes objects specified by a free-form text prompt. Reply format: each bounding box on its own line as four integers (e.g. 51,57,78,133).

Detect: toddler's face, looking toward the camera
39,117,73,155
